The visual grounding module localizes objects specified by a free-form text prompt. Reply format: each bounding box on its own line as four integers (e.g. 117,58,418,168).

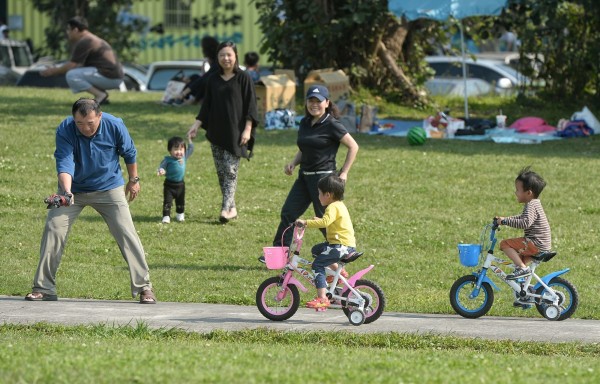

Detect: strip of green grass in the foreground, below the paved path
0,324,600,384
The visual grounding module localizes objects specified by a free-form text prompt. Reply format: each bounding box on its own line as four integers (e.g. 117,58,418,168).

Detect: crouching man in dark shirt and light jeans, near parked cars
40,16,123,105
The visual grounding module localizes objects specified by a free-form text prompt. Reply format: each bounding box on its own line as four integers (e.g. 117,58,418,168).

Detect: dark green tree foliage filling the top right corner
497,0,600,106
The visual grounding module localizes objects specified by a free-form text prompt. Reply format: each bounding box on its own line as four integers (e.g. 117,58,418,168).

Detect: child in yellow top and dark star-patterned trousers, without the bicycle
296,175,356,309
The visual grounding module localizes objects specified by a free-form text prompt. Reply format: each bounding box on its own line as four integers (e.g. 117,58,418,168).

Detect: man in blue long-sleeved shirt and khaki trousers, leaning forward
25,99,156,304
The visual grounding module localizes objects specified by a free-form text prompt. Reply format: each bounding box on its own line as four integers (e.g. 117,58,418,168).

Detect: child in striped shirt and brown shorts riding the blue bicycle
496,167,552,280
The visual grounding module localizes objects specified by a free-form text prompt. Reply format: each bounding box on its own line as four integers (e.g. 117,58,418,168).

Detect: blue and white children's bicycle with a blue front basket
450,219,579,320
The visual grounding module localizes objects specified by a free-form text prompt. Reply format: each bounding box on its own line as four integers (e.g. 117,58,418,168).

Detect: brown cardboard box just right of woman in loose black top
255,75,296,125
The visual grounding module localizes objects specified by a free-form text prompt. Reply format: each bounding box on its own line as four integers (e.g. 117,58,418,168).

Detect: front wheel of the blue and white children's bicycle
450,275,494,319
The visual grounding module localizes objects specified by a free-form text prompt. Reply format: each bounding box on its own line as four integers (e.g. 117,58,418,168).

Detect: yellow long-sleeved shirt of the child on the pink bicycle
306,200,356,247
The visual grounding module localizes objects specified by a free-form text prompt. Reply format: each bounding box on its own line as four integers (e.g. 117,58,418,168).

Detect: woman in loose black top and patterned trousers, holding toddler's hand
188,41,258,223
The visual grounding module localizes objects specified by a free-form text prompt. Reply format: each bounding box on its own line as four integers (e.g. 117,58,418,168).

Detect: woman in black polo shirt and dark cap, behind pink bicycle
260,85,358,262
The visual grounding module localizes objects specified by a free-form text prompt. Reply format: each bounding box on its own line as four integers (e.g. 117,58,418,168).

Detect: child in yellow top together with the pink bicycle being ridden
256,175,385,325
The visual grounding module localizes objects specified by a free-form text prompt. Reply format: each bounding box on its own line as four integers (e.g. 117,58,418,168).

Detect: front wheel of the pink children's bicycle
256,276,300,321
